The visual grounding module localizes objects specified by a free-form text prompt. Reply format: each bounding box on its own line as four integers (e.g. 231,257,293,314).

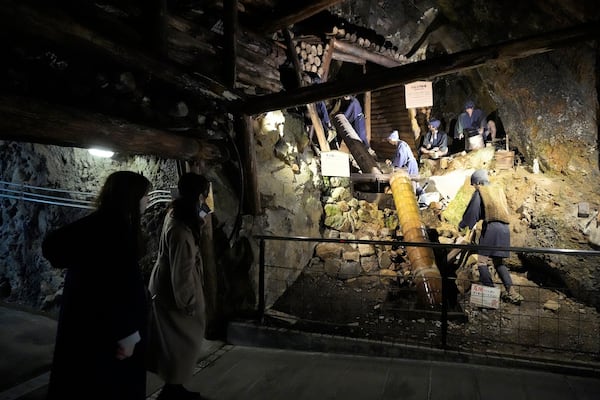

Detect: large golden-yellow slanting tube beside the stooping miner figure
390,170,442,309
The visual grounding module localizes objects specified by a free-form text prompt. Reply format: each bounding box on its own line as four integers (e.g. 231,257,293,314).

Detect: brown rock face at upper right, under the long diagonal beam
481,48,599,179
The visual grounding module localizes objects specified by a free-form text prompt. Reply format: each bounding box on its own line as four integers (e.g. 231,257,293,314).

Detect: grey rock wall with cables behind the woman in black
0,142,177,309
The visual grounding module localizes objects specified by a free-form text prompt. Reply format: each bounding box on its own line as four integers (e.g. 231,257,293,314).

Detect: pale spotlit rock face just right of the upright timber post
252,109,323,306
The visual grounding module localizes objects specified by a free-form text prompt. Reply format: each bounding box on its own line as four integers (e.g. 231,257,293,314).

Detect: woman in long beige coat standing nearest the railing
149,173,209,400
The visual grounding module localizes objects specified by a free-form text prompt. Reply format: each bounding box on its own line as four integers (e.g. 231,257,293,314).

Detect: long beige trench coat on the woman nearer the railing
148,211,206,384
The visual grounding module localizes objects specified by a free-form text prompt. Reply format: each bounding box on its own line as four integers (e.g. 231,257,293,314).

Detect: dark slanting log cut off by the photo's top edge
256,0,343,33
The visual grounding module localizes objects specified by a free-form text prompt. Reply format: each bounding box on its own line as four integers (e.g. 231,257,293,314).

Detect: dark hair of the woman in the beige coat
171,172,210,241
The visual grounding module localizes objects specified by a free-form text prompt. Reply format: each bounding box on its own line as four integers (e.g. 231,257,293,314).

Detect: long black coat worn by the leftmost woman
43,212,147,400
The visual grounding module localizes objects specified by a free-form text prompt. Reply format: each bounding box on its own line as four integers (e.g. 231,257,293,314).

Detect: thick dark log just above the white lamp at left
0,95,203,160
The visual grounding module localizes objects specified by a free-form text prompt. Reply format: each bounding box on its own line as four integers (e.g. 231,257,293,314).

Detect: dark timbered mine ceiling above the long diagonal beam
0,0,599,159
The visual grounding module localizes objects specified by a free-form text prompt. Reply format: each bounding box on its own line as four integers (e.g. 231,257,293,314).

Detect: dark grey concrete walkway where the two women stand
0,307,600,400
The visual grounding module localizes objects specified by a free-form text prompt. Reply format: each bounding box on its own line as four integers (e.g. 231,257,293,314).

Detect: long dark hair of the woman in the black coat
96,171,152,255
